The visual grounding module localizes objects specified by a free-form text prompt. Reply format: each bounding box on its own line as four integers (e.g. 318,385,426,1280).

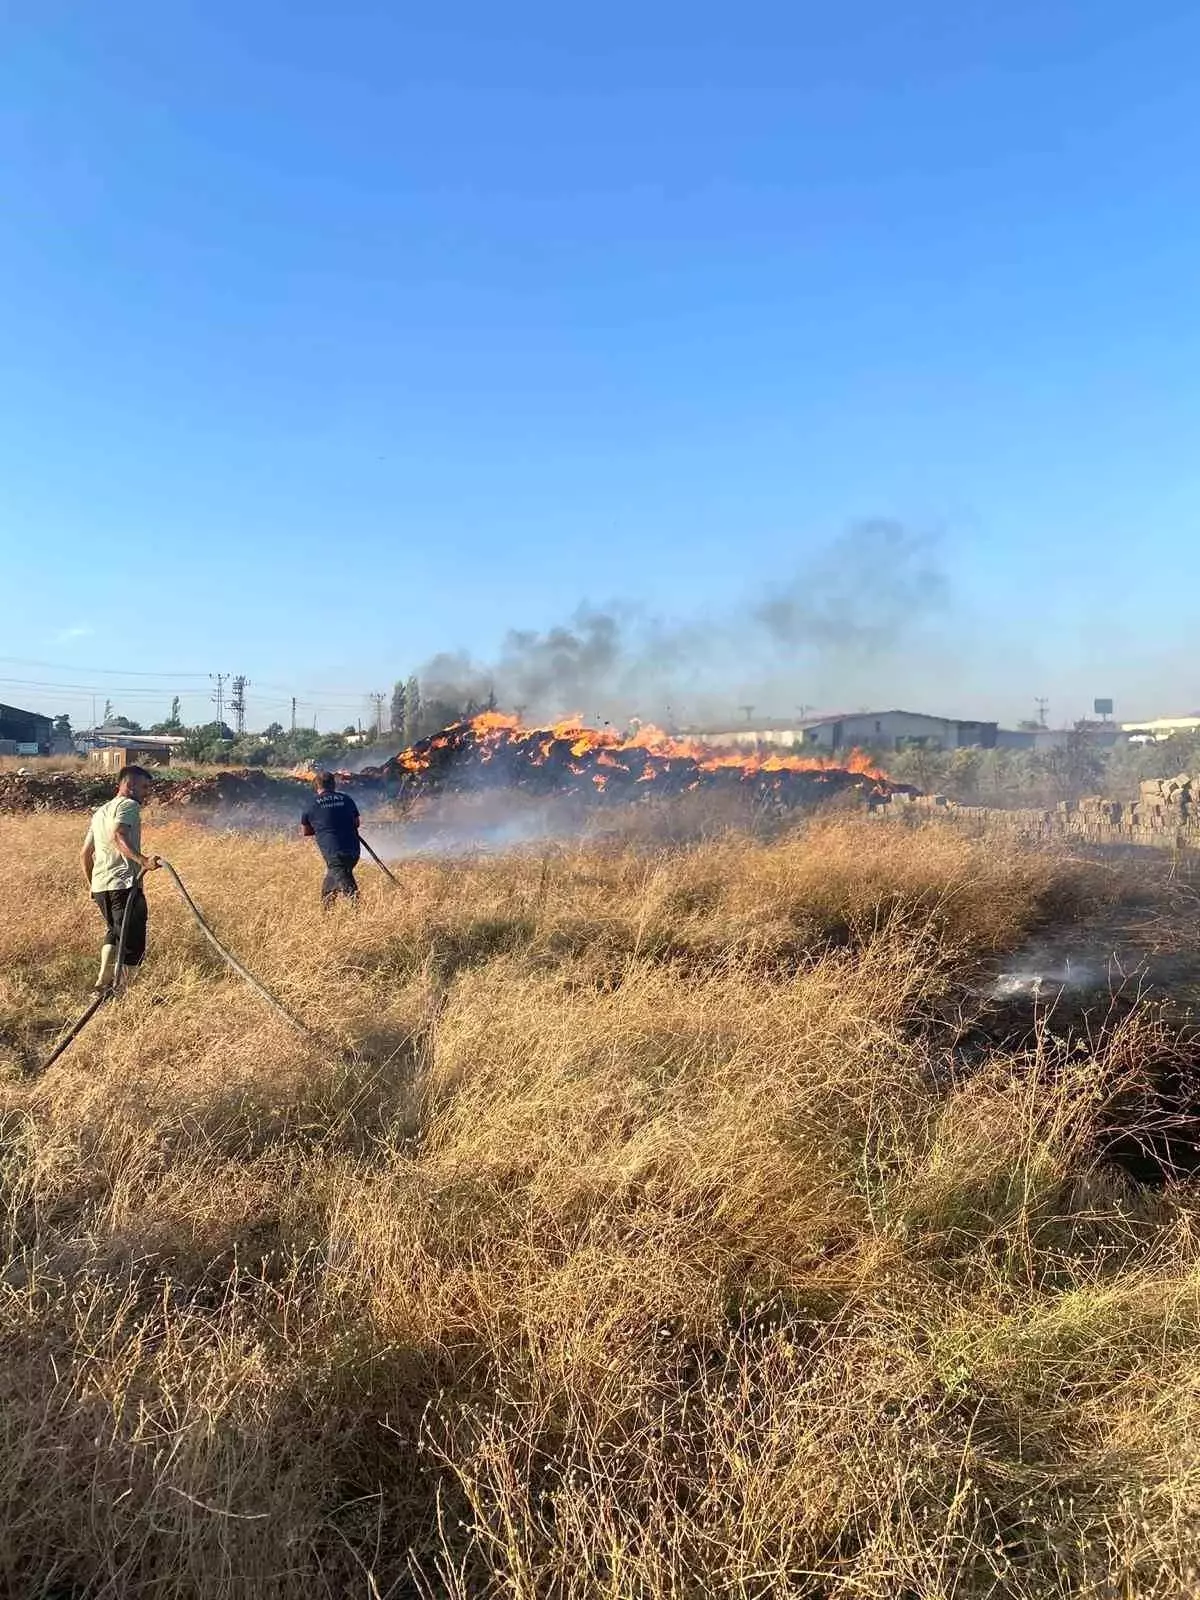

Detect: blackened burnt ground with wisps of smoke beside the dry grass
952,846,1200,1184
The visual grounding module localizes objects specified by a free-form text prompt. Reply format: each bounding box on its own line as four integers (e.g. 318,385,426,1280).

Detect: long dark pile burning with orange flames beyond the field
366,712,915,806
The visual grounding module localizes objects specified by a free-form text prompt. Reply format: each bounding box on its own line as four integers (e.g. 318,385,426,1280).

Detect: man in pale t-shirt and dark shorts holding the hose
80,766,158,994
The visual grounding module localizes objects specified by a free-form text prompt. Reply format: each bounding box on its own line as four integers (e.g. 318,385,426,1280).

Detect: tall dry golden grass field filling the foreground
0,813,1200,1600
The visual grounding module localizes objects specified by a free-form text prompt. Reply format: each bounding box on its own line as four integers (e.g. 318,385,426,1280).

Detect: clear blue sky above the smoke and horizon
0,0,1200,725
